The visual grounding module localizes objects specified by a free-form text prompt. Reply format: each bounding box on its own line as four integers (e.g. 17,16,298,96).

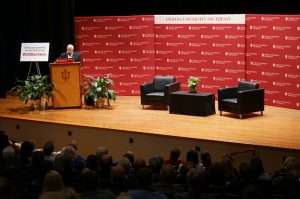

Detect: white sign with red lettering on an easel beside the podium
20,43,49,78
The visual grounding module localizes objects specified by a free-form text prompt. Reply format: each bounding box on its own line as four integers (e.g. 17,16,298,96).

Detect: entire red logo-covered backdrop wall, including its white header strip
75,15,300,109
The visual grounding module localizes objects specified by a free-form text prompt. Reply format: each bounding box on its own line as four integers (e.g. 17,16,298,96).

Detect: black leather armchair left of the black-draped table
140,76,180,109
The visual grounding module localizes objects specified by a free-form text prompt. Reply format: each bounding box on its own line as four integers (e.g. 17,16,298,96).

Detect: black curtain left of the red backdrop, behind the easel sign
0,0,75,97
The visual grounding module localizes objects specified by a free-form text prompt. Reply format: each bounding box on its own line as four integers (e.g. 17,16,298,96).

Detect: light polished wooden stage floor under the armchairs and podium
0,96,300,150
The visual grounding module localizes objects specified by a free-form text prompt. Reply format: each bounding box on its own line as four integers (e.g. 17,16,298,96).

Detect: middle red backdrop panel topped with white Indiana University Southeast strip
154,15,245,93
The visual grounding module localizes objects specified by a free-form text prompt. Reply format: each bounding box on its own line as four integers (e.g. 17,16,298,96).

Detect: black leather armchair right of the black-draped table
218,81,264,119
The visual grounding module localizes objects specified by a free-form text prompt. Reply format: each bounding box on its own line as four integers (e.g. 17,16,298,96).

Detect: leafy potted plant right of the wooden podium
82,74,116,107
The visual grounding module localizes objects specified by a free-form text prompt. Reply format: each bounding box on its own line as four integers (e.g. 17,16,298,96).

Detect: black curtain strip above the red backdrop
74,0,300,16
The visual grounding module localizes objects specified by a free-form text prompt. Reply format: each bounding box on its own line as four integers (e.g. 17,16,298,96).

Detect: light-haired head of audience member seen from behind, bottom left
43,170,65,192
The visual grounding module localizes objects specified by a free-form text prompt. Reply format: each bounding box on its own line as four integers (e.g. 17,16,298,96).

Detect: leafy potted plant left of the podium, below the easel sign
10,75,55,109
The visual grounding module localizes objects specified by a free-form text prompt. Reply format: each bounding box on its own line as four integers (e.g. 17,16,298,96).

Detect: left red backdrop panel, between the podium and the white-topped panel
75,16,155,95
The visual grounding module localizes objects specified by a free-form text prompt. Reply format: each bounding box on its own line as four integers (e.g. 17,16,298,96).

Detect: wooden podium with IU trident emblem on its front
50,62,81,108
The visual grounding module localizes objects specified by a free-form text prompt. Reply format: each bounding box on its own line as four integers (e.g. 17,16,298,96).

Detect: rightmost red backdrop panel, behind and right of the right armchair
246,15,300,109
